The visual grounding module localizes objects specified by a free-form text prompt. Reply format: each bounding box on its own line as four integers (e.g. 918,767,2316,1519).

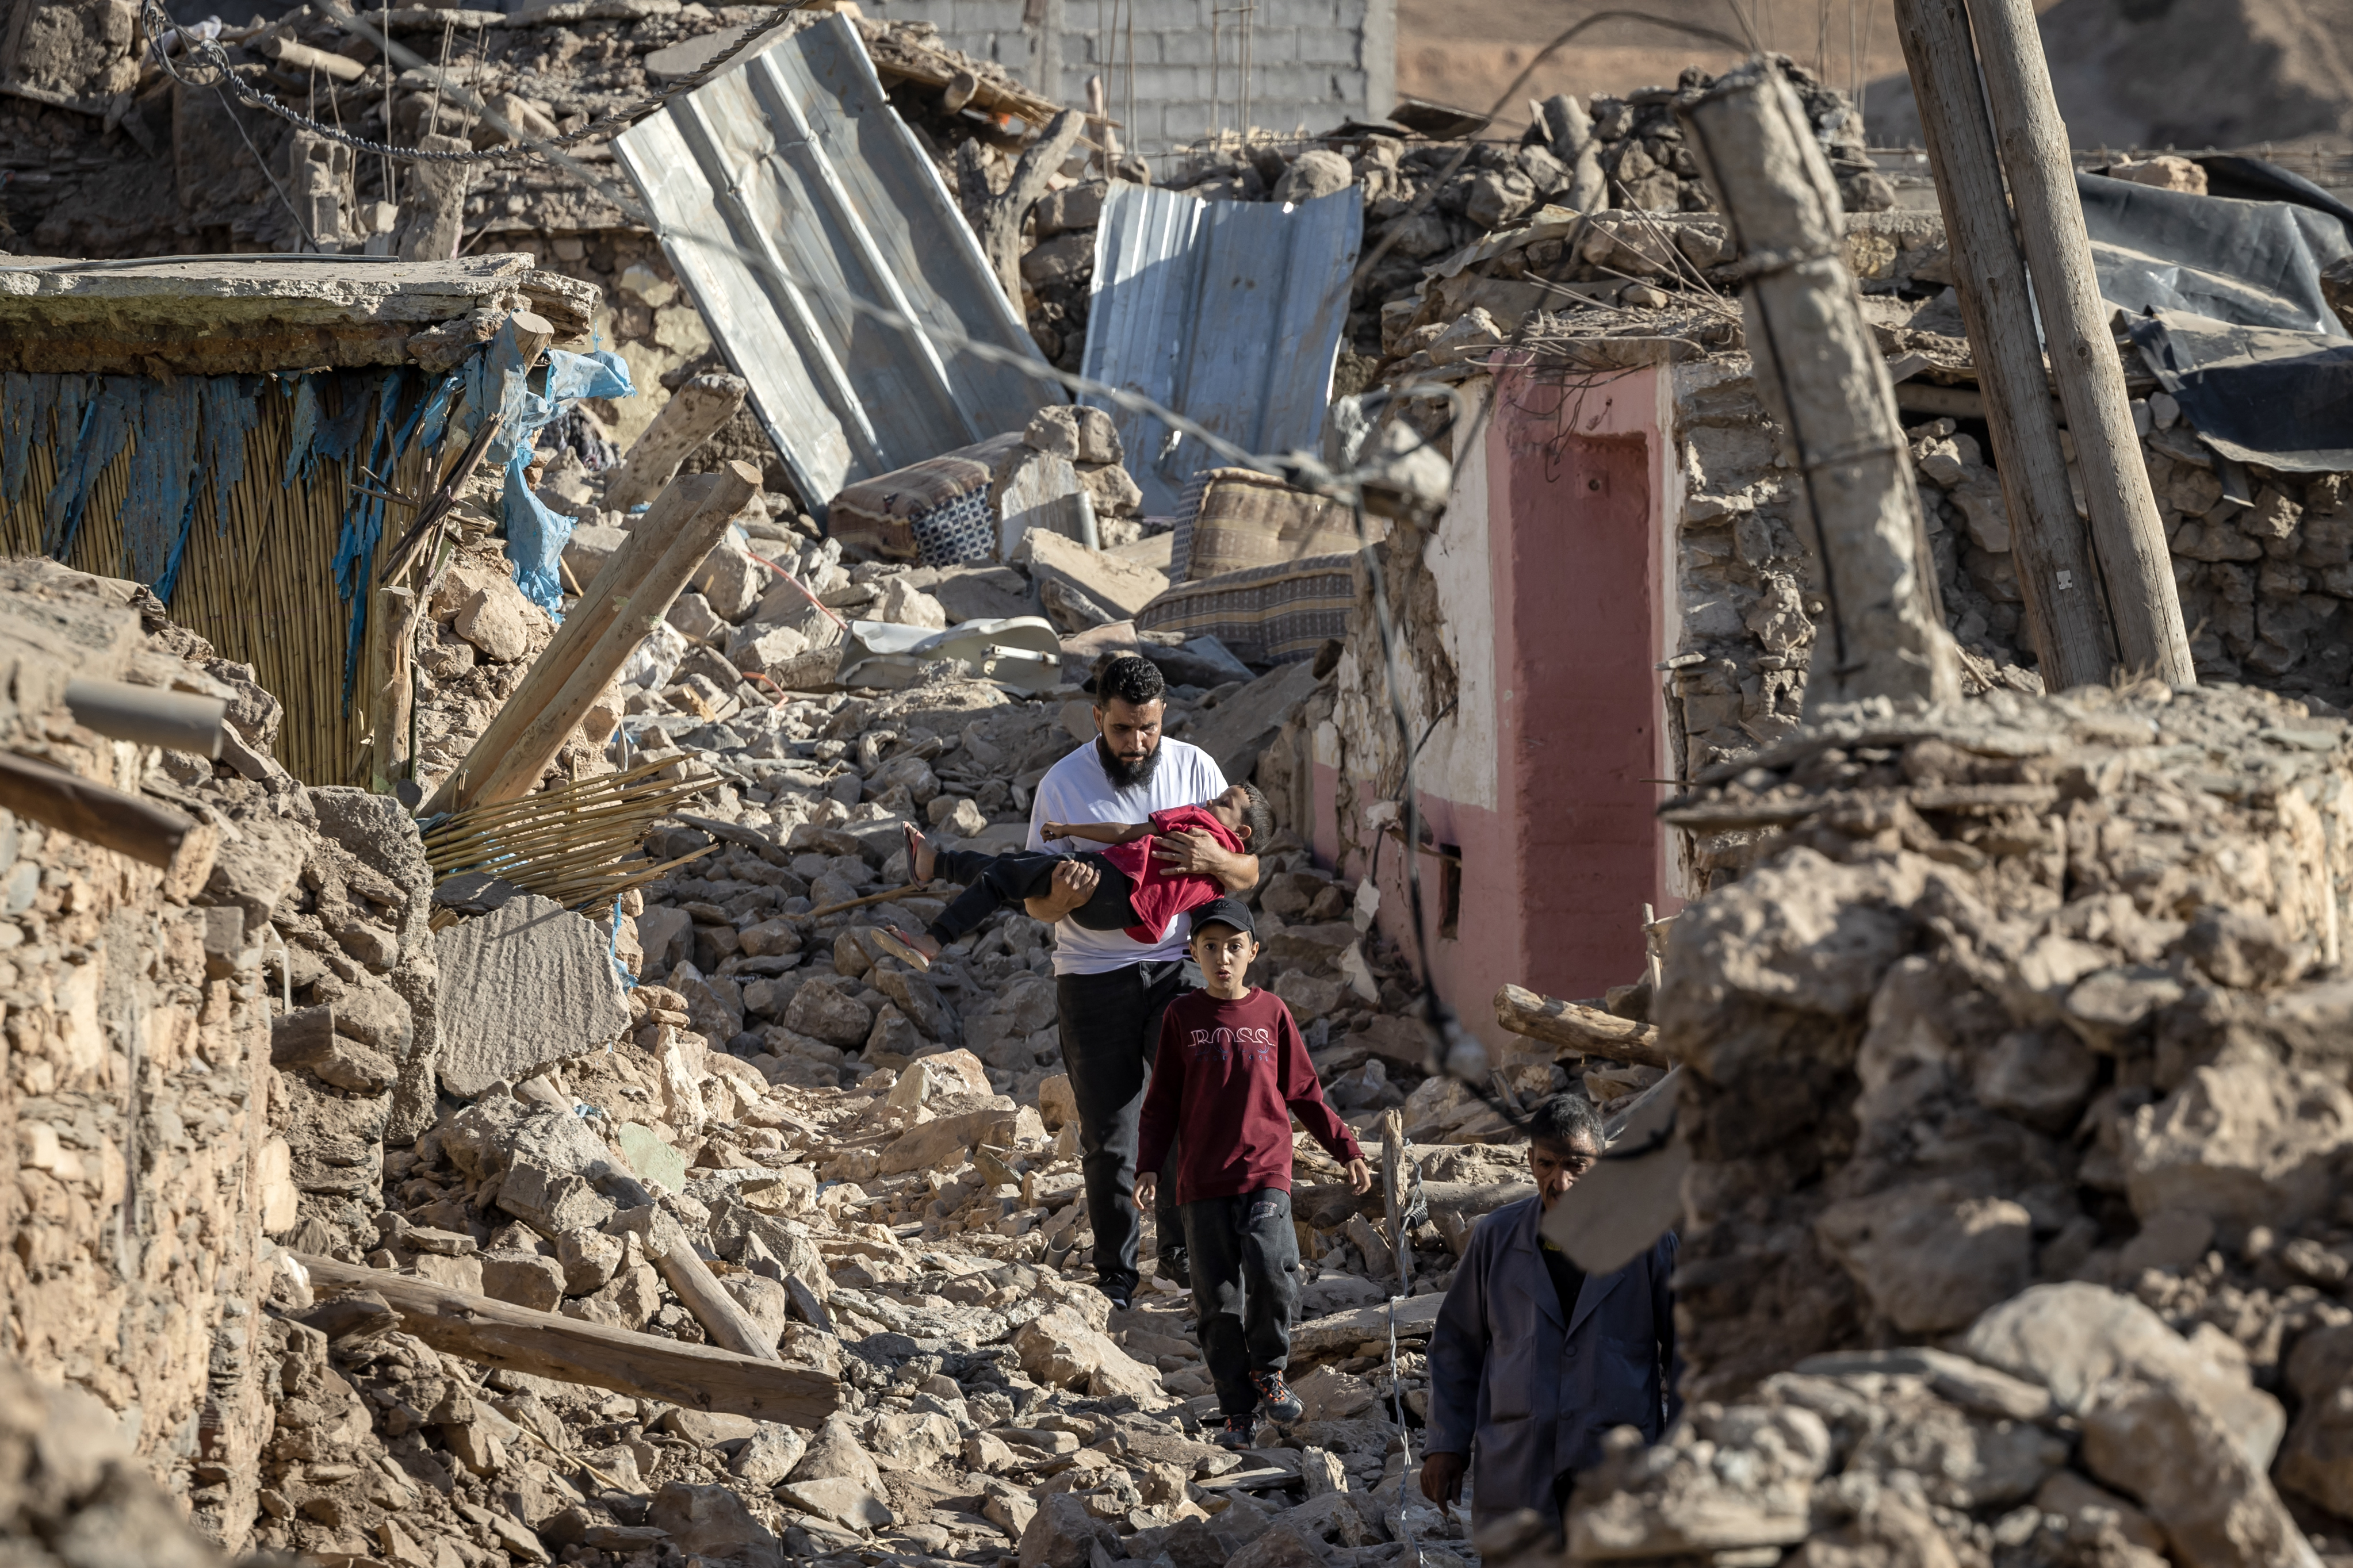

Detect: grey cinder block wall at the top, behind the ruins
868,0,1398,155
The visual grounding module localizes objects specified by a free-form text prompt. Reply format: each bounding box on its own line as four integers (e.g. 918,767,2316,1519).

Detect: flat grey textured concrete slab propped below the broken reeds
433,894,628,1100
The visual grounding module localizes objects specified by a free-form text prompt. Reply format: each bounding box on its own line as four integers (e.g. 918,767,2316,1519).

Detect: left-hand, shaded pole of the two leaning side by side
1896,0,2120,691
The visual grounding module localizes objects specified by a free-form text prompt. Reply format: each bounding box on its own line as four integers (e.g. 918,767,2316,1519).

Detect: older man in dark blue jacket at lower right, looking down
1421,1093,1680,1525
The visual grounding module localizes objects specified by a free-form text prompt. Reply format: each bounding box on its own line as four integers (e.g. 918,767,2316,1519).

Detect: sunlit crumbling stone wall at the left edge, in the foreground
0,562,322,1547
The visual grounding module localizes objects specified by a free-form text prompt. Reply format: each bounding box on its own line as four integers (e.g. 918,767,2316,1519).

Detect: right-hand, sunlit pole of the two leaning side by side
1969,0,2198,687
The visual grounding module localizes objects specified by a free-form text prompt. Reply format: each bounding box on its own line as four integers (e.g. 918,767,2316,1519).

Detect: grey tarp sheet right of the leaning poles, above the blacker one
2075,158,2353,341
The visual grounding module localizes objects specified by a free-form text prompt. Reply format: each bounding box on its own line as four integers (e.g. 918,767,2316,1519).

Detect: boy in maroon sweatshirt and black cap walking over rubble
1137,898,1372,1448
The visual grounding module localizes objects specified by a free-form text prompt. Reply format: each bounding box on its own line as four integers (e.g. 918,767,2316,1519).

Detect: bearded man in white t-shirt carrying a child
1026,654,1259,1307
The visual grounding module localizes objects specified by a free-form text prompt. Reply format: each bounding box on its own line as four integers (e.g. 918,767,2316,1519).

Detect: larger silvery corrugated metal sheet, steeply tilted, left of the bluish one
614,14,1061,508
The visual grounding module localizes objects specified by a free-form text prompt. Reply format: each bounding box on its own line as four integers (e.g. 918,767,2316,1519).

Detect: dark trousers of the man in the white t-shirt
1054,959,1186,1295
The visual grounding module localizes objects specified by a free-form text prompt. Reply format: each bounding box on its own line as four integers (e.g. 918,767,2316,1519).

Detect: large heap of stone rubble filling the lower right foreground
1572,682,2353,1563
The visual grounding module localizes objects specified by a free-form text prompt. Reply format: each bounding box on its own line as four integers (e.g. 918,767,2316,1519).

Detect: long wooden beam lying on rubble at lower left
294,1253,843,1427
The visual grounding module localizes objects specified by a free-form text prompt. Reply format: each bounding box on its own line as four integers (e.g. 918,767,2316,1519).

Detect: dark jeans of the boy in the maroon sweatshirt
1184,1187,1299,1415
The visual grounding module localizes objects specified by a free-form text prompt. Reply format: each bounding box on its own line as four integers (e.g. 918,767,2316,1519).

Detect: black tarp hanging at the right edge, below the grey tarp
2109,310,2353,473
